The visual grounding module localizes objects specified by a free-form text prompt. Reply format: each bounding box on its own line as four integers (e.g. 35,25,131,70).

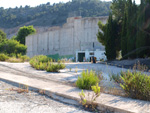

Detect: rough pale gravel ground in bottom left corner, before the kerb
0,80,89,113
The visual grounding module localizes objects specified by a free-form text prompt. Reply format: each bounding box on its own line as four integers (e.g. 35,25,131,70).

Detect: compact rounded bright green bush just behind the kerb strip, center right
76,70,100,89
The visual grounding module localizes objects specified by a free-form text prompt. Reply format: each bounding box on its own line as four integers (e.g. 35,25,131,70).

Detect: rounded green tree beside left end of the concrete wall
16,26,36,45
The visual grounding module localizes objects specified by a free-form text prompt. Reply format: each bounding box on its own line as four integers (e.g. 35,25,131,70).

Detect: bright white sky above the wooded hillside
0,0,140,8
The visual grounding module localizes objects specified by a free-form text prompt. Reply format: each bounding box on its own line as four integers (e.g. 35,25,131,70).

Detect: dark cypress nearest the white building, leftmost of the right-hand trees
97,14,121,60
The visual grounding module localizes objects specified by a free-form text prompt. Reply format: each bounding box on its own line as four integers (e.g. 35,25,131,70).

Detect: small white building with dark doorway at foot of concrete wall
76,49,106,62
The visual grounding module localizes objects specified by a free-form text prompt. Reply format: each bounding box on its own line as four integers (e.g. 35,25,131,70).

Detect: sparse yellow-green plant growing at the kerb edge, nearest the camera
79,83,100,111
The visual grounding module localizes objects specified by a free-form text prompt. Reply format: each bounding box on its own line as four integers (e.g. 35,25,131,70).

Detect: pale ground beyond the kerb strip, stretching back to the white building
0,62,131,87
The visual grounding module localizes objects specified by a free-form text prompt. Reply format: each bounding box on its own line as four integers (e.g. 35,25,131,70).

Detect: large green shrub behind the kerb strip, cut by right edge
120,71,150,101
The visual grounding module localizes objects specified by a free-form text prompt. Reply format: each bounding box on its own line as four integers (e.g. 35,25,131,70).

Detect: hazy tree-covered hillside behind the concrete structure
0,0,111,29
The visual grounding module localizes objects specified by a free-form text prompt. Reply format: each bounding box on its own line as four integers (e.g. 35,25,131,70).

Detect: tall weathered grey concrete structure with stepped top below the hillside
26,17,108,57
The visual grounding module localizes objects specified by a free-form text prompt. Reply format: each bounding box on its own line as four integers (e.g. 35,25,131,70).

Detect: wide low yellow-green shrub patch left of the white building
30,55,66,72
